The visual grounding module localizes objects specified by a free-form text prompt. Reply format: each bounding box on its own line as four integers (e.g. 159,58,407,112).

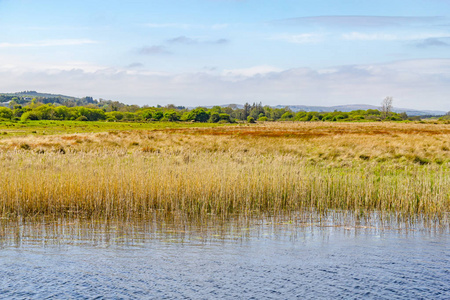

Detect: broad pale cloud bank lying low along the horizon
0,59,450,111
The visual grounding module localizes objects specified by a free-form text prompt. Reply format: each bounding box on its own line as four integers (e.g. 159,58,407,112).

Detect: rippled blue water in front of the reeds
0,212,450,299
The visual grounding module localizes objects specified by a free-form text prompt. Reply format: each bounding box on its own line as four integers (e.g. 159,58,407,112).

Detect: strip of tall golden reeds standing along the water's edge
0,153,450,217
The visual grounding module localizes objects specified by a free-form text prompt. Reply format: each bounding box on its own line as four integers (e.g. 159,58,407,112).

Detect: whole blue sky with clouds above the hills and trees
0,0,450,111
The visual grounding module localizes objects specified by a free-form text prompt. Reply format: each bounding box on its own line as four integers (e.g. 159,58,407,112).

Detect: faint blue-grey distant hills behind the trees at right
221,104,447,116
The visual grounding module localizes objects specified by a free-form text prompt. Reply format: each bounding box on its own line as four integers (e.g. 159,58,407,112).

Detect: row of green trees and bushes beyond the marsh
0,99,412,123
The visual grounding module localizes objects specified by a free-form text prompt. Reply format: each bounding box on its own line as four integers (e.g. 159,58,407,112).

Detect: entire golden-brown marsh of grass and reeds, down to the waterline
0,123,450,221
